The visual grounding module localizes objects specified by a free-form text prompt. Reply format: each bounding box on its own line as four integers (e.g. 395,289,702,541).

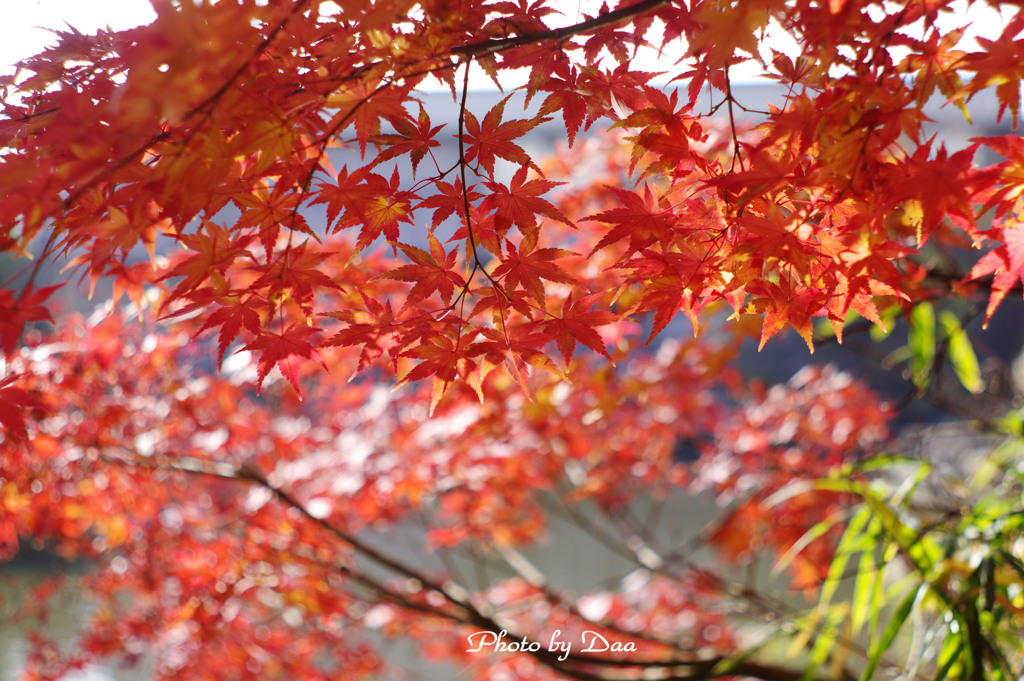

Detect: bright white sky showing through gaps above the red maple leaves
0,0,1013,89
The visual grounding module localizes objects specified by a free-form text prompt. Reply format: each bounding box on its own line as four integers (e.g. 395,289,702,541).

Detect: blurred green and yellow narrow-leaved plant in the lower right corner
773,438,1024,681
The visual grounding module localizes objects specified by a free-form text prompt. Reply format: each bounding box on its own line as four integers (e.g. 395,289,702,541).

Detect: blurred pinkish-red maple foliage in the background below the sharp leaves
0,309,888,679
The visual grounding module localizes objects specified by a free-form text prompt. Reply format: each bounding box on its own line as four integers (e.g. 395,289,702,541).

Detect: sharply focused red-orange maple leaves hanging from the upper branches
0,0,1022,407
